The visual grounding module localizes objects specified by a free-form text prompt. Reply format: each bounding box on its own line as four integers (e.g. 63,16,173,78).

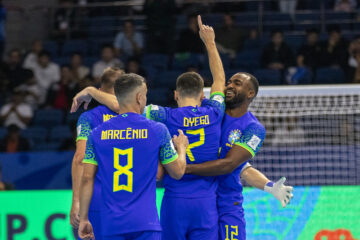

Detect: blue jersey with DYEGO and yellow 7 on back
146,93,225,198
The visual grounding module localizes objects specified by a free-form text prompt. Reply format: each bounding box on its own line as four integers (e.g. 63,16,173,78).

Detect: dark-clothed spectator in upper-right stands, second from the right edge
321,26,348,69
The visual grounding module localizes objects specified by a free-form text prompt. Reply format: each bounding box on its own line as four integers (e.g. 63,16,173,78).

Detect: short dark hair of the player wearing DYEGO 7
176,72,204,97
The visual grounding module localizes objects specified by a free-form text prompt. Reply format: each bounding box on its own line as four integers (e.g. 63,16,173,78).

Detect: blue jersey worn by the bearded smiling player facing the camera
217,112,265,209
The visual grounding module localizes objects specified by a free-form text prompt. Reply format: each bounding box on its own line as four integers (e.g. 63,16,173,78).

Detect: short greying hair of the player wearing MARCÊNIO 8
114,73,146,103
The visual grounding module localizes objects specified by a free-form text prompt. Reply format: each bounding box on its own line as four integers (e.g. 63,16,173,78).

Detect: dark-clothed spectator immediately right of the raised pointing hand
215,14,248,58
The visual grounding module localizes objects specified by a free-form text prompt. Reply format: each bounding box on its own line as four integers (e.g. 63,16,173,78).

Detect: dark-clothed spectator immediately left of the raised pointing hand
177,15,204,53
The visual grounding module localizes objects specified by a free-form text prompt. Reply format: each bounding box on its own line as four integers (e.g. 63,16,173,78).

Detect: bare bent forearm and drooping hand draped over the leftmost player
70,87,119,113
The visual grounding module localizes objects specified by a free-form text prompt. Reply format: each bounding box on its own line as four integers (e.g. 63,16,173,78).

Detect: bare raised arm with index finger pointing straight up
198,15,225,93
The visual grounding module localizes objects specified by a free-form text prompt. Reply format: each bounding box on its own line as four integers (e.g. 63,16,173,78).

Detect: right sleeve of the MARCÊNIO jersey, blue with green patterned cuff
157,124,178,165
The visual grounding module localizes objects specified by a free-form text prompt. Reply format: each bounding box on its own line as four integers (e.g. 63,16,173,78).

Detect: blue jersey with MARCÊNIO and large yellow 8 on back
83,113,178,236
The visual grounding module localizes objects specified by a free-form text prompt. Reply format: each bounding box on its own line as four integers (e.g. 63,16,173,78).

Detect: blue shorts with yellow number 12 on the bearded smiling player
218,206,246,240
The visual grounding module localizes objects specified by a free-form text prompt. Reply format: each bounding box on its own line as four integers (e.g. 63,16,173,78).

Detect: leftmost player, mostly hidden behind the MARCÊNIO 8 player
70,68,124,240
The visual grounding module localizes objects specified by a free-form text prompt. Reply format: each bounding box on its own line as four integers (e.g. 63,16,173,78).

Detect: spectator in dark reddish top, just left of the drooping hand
46,65,79,110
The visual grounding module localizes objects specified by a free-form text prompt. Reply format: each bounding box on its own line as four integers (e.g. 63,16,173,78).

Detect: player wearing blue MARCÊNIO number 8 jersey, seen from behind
79,74,188,240
